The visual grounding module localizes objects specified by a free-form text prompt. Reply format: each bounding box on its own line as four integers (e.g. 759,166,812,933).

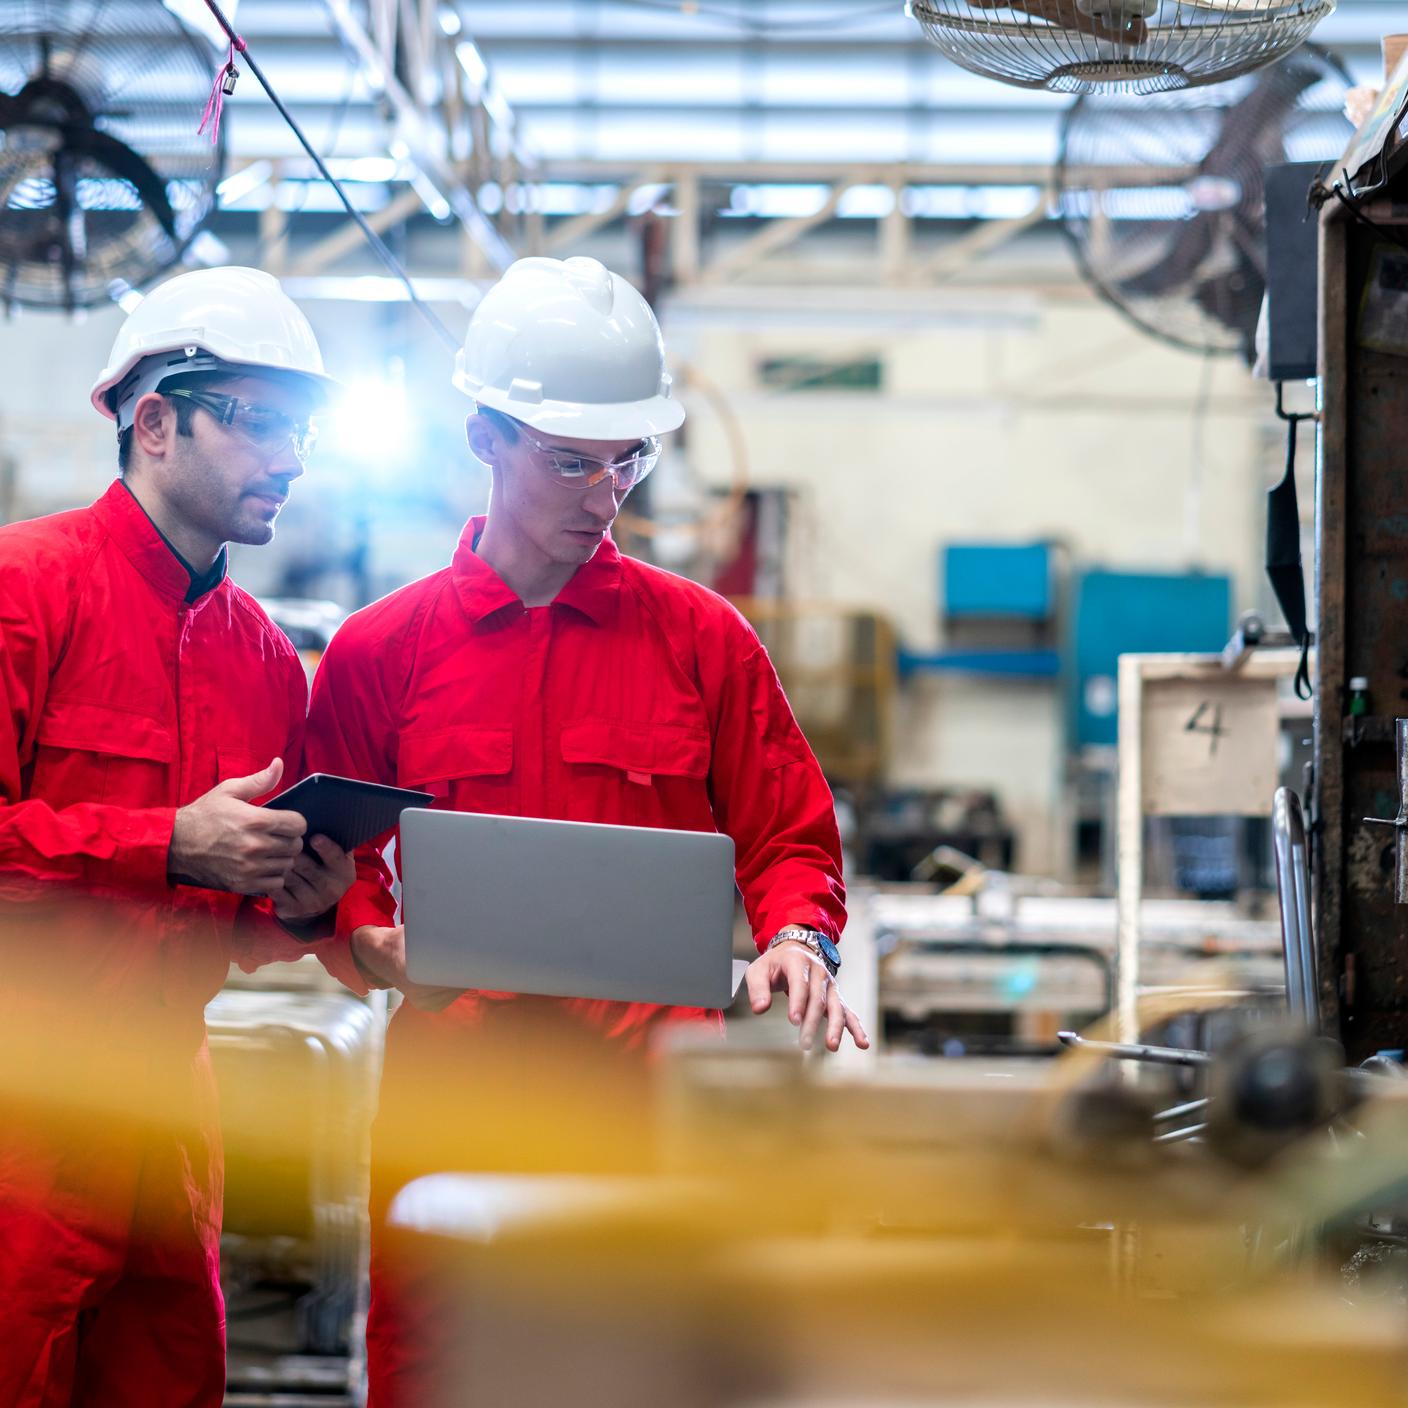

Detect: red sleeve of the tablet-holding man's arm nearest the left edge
0,542,176,900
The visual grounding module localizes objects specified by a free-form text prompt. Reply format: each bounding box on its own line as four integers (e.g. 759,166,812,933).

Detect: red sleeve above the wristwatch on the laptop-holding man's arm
700,618,846,950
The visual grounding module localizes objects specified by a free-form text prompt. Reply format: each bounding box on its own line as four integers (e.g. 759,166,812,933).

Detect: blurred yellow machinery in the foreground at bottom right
360,1013,1408,1408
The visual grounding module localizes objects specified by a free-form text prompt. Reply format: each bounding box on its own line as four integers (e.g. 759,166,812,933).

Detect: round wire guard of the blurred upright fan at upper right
1055,45,1350,360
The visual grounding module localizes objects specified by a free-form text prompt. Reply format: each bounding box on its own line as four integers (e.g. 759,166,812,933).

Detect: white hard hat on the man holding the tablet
92,266,338,427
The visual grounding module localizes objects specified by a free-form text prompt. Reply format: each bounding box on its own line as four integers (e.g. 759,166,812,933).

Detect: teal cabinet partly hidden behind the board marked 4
1069,570,1232,748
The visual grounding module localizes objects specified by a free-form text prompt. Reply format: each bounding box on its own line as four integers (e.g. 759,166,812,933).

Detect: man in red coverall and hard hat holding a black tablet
0,269,353,1408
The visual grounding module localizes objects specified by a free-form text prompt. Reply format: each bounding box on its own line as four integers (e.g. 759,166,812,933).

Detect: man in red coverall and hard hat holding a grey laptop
308,259,869,1408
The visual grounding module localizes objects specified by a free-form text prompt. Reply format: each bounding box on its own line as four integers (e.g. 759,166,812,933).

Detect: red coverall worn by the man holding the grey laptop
307,518,845,1408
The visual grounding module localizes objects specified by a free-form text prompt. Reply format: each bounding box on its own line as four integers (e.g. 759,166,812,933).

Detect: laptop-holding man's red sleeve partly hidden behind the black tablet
306,629,396,994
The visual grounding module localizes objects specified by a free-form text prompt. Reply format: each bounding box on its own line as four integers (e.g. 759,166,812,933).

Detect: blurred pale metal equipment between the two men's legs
206,957,386,1394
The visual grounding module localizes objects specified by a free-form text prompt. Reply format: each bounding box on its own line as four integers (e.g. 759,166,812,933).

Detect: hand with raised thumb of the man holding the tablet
168,758,308,894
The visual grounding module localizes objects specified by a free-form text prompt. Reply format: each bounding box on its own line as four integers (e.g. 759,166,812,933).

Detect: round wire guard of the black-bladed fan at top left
0,0,224,308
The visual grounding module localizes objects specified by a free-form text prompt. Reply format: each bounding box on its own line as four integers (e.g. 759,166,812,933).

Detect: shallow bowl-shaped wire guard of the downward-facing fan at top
910,0,1335,94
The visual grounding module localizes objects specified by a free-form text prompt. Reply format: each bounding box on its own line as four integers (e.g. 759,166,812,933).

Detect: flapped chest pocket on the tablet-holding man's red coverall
30,700,176,807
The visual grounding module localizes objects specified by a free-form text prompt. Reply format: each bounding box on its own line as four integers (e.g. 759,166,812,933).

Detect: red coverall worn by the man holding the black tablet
0,483,307,1408
